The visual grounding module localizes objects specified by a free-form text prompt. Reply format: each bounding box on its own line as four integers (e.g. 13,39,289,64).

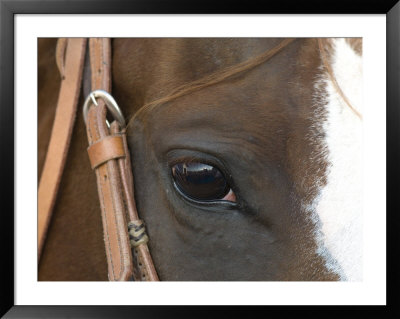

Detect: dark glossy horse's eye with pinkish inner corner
172,162,236,202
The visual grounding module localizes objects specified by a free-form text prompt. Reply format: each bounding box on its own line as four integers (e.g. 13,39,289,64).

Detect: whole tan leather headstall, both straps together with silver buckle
38,38,158,281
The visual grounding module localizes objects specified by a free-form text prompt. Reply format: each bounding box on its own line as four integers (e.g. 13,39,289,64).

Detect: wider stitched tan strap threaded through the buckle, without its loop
86,39,133,281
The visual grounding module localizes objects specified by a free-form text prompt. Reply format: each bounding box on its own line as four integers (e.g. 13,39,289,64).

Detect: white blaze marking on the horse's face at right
314,39,363,281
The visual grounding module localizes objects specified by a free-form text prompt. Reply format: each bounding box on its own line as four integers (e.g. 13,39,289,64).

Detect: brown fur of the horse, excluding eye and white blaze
38,38,360,281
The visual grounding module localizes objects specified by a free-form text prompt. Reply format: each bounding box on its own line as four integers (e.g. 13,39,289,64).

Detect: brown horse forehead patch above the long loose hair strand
113,38,288,107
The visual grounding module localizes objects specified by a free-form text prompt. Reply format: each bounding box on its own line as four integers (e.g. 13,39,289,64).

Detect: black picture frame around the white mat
0,0,400,318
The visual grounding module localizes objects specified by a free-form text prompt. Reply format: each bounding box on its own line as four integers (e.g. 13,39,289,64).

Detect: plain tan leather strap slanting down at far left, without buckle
38,38,86,261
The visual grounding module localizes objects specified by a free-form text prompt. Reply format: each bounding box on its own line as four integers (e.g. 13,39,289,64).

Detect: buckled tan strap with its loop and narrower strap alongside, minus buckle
86,38,158,281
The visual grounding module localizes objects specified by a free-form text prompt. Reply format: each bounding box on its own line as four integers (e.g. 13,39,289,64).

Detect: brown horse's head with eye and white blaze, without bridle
38,38,362,281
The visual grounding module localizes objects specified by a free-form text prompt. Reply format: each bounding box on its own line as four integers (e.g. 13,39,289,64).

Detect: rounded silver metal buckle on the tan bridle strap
83,90,126,129
